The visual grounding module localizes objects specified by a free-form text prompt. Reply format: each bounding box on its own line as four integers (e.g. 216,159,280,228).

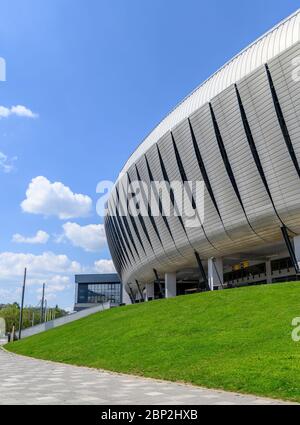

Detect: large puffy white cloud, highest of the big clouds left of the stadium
21,176,92,220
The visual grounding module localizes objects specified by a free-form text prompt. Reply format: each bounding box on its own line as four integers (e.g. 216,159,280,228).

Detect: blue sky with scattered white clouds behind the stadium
0,0,299,307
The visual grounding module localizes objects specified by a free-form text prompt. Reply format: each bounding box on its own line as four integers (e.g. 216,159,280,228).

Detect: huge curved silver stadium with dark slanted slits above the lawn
105,11,300,302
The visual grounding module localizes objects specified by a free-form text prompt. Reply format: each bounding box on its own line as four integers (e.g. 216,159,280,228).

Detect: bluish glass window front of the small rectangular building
78,283,122,304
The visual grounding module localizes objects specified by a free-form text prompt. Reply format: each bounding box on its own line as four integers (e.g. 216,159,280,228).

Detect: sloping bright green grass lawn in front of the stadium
6,283,300,402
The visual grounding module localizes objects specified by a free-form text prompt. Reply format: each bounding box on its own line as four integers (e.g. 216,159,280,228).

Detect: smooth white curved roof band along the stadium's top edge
121,10,300,179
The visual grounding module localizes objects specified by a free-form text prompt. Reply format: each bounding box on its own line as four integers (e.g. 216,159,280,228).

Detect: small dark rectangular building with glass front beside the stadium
75,274,123,311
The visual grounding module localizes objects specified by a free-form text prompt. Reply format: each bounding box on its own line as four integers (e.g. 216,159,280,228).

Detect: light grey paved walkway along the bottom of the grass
0,349,290,405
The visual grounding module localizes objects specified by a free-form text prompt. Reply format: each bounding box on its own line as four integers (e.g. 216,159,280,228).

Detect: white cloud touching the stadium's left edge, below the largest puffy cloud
58,223,106,252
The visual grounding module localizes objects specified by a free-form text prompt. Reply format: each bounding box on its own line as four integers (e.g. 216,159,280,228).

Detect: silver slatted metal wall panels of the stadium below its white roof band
106,13,300,284
